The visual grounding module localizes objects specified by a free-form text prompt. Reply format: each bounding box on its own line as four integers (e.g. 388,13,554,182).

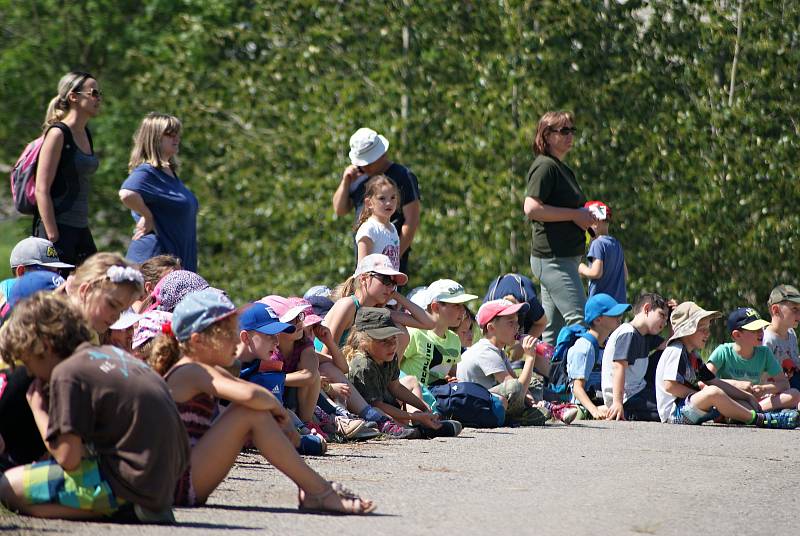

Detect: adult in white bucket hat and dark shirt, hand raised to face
333,128,420,273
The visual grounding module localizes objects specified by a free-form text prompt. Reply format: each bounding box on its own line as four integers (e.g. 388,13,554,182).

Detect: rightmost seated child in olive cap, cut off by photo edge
764,285,800,389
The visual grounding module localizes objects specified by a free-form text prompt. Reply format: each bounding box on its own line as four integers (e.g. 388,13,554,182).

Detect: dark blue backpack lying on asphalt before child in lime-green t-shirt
430,382,506,428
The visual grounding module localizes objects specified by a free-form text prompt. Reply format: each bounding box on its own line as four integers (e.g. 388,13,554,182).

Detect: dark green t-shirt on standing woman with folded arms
525,155,586,258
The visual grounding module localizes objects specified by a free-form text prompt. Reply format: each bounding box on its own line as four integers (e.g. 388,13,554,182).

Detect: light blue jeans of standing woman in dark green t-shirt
531,256,586,346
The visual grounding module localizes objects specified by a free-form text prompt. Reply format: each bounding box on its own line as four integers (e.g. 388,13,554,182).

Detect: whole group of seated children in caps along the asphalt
0,232,800,522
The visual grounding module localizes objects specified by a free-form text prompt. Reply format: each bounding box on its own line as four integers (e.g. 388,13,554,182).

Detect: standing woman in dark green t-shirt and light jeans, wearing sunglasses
524,112,595,344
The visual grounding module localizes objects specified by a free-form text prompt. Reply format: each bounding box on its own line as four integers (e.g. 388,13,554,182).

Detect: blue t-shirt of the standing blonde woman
122,164,199,272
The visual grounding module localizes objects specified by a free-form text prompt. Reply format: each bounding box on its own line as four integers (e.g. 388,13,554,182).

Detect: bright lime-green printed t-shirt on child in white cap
400,328,461,385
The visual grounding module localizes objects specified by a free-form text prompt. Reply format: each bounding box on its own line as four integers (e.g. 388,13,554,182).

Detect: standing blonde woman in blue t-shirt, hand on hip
119,112,199,272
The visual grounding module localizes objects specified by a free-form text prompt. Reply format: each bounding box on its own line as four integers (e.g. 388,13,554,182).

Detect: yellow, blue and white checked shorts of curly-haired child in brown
22,459,126,515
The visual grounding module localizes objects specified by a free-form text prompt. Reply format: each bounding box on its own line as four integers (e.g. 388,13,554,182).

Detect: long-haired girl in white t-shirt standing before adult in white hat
355,175,400,270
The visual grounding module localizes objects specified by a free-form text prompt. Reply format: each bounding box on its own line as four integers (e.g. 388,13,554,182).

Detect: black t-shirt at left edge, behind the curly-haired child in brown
0,367,46,465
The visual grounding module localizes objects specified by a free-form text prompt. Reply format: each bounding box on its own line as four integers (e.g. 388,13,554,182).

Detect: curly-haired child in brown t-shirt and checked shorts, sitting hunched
0,294,189,522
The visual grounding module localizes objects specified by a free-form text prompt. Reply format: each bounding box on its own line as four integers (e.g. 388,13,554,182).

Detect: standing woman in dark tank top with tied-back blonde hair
33,71,103,266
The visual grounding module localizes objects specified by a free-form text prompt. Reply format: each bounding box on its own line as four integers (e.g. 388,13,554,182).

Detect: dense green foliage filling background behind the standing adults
0,0,800,324
